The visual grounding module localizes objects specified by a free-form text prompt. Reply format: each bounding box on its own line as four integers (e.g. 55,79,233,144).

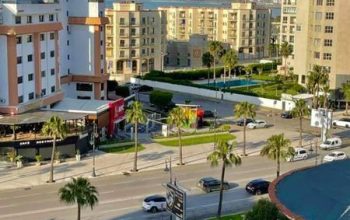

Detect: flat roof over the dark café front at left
0,110,87,125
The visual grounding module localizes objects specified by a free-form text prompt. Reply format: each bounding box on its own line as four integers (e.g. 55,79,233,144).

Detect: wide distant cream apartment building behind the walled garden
158,0,271,59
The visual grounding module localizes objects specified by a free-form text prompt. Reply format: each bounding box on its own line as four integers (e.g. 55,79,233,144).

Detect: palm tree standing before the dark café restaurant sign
41,115,67,183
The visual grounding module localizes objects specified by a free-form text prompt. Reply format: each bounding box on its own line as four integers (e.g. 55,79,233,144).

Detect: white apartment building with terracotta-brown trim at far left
0,0,108,114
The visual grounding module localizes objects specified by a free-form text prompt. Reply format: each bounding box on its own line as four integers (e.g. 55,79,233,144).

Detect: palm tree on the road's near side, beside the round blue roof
260,134,294,177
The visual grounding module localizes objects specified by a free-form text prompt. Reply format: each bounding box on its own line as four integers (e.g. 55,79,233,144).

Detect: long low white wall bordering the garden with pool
130,78,290,110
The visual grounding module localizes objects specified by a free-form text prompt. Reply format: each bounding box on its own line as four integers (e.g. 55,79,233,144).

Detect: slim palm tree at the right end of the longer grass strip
234,102,256,156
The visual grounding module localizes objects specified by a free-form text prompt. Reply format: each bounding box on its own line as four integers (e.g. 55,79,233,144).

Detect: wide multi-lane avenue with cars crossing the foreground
0,156,315,220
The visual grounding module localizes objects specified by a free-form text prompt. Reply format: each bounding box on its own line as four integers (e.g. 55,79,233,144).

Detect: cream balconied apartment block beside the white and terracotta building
105,1,166,82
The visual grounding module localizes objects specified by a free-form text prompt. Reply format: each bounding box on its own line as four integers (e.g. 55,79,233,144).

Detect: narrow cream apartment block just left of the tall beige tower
279,0,297,67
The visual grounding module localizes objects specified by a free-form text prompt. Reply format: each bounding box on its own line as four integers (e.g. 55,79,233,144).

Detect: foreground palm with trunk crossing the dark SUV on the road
207,140,242,217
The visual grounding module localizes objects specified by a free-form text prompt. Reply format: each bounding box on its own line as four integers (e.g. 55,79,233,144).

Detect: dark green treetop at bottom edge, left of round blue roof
245,199,288,220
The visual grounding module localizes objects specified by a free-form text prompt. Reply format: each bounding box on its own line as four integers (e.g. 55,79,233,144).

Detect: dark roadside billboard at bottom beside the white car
166,183,186,219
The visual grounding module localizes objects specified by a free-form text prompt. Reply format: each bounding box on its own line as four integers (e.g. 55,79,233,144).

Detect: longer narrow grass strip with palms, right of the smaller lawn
156,133,236,147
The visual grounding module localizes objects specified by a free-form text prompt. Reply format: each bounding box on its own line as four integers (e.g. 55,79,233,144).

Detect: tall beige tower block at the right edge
295,0,350,89
